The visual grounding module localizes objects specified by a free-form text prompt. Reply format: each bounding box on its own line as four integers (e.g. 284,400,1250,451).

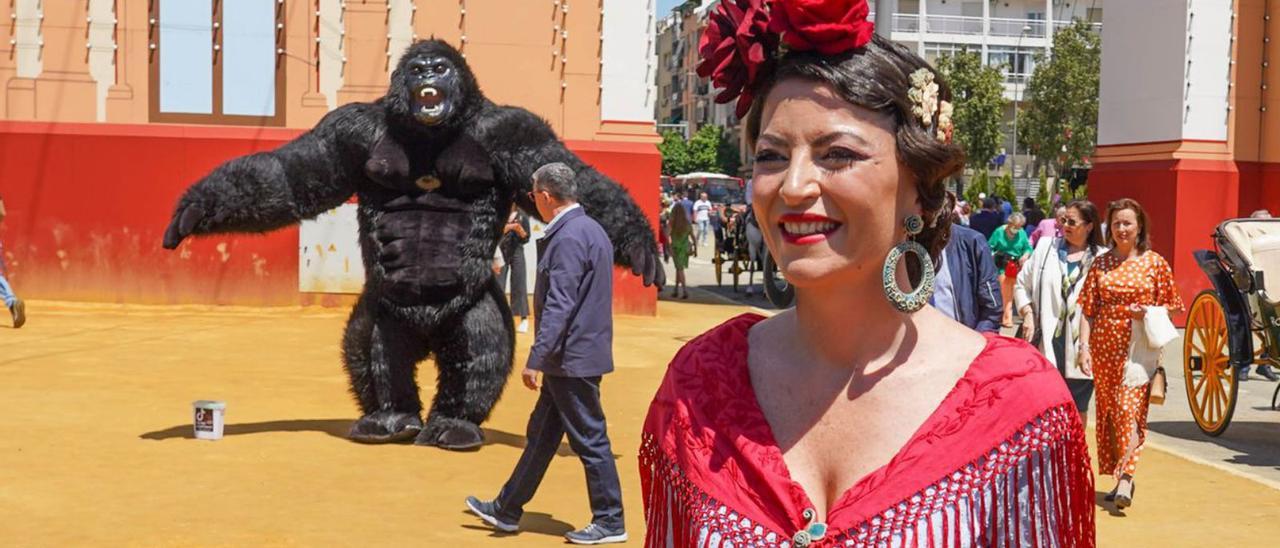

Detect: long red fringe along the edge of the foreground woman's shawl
639,403,1096,548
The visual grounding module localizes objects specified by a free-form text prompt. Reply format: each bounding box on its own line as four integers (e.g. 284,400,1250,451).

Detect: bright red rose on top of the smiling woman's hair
769,0,876,55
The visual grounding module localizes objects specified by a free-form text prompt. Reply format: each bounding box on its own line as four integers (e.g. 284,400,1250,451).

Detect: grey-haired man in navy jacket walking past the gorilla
466,163,627,544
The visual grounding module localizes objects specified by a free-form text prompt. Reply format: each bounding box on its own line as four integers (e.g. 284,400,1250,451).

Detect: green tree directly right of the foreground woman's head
937,50,1006,177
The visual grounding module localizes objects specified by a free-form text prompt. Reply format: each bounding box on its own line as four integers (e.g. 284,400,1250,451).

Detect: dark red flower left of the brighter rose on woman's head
698,0,778,118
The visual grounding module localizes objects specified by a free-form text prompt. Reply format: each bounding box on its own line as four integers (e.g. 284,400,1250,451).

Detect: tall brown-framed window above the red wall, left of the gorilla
150,0,284,125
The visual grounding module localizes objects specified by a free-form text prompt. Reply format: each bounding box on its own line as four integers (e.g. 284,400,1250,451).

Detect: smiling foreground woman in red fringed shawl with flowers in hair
640,0,1094,548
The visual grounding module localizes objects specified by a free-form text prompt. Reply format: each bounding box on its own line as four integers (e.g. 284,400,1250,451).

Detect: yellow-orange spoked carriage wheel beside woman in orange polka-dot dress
1183,289,1239,437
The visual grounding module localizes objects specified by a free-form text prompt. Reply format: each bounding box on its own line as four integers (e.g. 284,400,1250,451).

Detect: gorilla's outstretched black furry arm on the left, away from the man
164,104,381,250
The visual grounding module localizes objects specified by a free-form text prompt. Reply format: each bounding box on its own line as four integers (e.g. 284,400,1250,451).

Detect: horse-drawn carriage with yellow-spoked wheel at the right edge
1183,219,1280,437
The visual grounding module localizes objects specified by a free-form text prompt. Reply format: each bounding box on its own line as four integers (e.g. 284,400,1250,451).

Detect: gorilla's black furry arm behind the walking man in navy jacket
471,106,666,288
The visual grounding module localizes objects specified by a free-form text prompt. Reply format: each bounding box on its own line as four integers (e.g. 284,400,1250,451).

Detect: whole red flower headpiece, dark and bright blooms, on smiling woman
698,0,876,118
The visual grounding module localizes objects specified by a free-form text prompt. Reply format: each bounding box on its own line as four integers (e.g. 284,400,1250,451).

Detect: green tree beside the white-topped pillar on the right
1018,20,1102,177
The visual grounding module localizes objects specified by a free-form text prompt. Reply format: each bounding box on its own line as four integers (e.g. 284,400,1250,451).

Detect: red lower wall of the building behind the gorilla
0,122,662,315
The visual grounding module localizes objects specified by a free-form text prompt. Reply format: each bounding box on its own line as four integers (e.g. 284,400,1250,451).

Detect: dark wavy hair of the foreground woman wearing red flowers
745,35,964,286
